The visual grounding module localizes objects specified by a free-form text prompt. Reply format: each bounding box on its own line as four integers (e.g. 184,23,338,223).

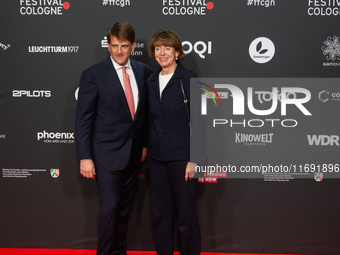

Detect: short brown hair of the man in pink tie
106,22,135,44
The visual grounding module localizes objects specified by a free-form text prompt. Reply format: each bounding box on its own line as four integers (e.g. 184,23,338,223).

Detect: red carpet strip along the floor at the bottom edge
0,248,302,255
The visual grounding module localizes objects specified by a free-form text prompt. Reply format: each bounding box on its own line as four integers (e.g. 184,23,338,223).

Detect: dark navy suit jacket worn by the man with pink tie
76,57,149,171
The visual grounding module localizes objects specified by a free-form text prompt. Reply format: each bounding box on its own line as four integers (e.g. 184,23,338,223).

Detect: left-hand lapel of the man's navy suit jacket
105,57,131,118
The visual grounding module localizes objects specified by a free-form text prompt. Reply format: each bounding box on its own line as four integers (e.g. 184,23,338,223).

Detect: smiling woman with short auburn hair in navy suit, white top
148,30,201,255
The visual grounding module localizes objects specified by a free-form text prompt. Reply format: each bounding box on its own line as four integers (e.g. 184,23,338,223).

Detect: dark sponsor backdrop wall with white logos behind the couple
0,0,340,254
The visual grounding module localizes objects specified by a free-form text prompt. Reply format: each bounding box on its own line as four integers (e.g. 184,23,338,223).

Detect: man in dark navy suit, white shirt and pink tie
76,22,149,255
